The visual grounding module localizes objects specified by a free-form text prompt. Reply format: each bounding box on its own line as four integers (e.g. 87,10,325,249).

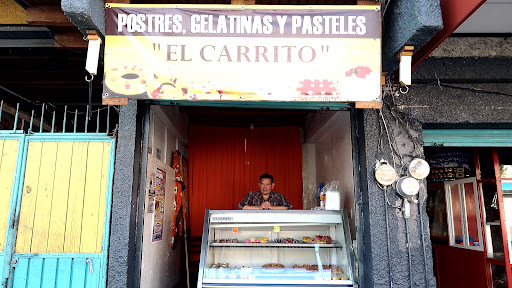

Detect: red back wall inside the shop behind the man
188,125,302,236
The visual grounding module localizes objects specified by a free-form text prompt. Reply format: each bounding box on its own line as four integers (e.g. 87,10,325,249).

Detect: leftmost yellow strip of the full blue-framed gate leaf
16,142,43,253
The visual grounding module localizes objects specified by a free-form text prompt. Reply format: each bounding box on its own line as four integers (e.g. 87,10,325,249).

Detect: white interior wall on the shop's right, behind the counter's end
302,111,355,237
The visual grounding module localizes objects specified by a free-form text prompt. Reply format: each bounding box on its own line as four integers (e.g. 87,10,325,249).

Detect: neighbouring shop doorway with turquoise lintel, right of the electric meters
425,130,512,287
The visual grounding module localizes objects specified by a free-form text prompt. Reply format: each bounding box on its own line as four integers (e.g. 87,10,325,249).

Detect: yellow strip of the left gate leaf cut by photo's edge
0,140,18,252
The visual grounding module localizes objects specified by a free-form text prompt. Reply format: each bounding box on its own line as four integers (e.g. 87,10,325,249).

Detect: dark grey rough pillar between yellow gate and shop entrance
107,100,142,288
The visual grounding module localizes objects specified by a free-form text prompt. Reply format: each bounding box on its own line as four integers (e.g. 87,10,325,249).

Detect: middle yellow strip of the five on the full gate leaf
48,142,73,253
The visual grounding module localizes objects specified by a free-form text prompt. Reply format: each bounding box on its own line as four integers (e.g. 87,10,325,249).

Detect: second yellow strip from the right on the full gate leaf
64,142,88,253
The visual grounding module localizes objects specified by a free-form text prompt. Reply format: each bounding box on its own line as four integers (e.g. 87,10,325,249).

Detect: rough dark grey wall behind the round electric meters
358,95,436,287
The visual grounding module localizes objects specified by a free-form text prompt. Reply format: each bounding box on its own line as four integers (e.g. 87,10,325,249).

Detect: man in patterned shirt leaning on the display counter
238,174,292,210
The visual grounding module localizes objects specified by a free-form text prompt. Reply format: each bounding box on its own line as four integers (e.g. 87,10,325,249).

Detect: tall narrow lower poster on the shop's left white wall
150,164,166,242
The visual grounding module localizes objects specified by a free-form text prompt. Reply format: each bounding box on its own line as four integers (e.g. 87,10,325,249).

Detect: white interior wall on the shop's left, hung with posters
140,108,186,288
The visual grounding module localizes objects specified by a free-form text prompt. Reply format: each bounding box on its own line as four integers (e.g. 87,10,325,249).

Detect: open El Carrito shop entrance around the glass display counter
141,105,356,287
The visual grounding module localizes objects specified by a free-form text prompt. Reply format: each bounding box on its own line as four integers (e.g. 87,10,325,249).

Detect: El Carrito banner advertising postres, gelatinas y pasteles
103,3,381,102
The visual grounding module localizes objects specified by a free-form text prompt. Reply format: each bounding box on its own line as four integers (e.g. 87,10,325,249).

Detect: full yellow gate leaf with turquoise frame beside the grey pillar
0,133,115,288
